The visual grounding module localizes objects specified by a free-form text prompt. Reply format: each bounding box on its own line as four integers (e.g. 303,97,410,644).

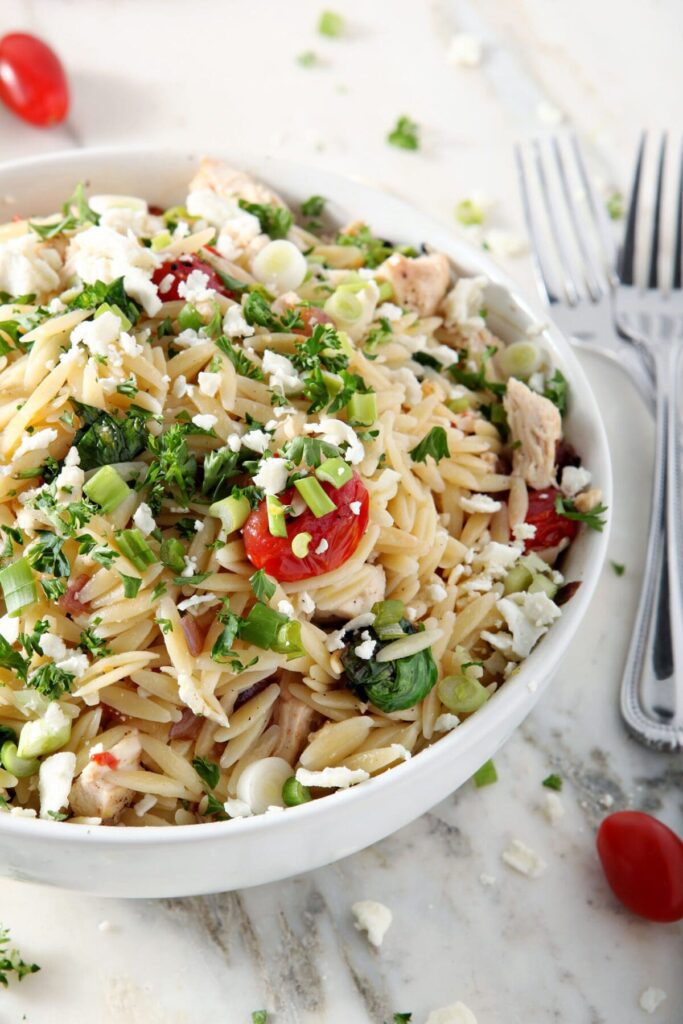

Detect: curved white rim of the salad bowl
0,144,612,847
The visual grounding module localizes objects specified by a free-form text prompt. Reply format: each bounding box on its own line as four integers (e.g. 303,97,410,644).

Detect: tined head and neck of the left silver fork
515,135,654,410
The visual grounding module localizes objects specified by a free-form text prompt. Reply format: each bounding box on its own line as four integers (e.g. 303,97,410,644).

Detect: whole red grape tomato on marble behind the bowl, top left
0,32,69,128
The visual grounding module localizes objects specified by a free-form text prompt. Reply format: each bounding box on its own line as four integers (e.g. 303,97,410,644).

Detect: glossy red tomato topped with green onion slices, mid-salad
244,473,370,583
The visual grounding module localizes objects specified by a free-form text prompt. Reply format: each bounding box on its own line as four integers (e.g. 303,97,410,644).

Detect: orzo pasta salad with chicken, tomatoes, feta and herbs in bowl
0,160,604,825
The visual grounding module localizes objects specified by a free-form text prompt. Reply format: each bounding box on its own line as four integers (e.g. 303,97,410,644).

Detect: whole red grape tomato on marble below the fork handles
597,811,683,922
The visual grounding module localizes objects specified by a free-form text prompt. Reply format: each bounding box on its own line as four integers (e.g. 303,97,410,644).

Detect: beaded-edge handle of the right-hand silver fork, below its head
622,344,683,749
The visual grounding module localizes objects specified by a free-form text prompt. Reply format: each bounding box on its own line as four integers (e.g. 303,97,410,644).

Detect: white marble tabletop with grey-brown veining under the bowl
0,0,683,1024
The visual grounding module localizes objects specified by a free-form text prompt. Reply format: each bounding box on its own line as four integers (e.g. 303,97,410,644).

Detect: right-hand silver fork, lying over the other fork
616,135,683,750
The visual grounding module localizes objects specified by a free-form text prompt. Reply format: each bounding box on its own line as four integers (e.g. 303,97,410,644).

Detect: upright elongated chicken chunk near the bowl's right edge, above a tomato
503,377,562,489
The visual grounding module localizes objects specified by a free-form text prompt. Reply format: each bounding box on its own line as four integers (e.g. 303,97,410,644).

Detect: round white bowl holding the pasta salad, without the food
0,148,611,897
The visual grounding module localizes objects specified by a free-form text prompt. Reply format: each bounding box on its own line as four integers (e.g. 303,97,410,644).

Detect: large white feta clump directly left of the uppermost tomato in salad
66,226,161,316
